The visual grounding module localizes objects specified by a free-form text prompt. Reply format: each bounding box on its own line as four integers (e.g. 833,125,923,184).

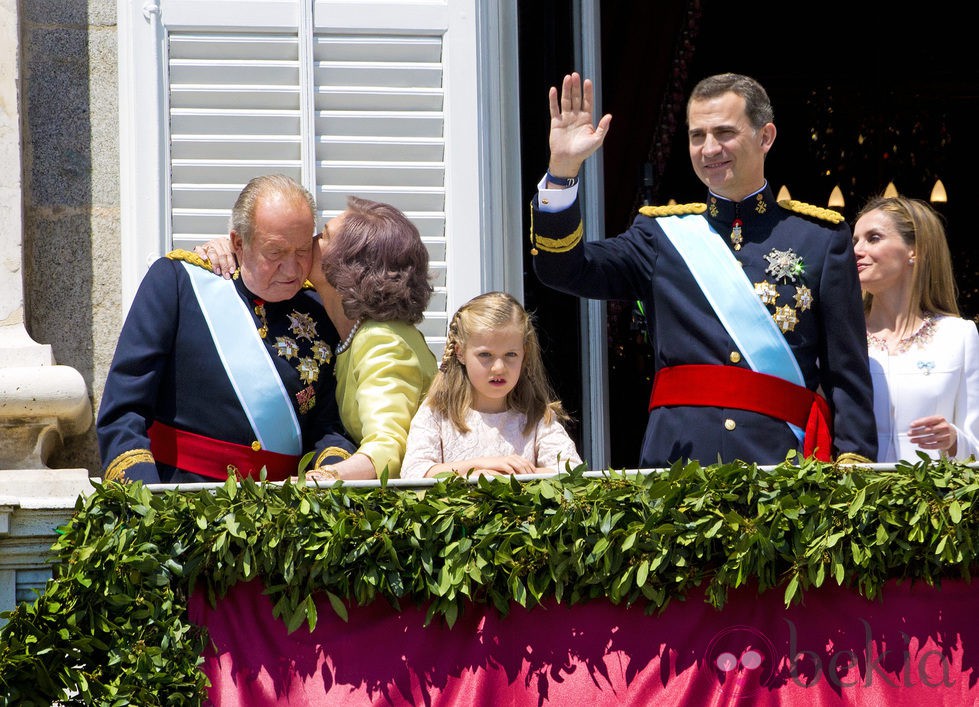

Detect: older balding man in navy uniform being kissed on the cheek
97,175,354,483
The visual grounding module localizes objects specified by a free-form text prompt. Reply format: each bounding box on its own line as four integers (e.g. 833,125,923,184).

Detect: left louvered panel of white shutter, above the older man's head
168,31,302,243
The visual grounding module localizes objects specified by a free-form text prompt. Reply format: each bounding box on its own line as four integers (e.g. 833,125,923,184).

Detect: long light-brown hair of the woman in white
857,196,959,334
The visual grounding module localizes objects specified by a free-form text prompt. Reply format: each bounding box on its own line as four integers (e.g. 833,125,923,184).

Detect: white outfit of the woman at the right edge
867,315,979,462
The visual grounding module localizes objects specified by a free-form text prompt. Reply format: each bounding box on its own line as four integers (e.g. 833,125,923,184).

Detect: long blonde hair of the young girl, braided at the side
426,292,568,434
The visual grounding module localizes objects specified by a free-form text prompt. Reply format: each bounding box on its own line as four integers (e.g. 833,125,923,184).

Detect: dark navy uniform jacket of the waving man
531,186,877,468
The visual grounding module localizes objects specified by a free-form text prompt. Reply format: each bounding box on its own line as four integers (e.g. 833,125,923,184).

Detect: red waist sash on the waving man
649,365,833,461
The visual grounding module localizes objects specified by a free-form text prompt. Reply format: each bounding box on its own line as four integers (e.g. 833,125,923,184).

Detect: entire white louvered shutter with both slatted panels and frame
122,0,479,352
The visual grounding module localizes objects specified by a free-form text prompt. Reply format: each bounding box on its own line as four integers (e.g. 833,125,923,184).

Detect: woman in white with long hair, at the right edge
853,197,979,462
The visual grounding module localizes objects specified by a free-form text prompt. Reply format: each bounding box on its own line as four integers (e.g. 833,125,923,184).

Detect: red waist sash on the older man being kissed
148,420,299,481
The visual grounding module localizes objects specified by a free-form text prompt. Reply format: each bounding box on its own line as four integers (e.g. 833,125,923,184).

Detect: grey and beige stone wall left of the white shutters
20,0,122,473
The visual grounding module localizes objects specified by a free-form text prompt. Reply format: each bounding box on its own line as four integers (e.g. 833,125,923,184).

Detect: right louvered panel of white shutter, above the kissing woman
313,30,446,338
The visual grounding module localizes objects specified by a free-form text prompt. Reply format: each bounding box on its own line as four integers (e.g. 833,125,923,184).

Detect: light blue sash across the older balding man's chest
183,263,302,454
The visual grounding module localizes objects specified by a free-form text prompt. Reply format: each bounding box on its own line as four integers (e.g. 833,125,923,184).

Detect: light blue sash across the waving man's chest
656,215,806,441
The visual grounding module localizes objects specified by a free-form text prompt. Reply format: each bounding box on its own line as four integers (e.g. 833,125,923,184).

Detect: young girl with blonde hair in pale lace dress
401,292,581,479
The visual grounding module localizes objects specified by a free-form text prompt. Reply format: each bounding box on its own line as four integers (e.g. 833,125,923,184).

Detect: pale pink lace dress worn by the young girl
401,404,581,479
